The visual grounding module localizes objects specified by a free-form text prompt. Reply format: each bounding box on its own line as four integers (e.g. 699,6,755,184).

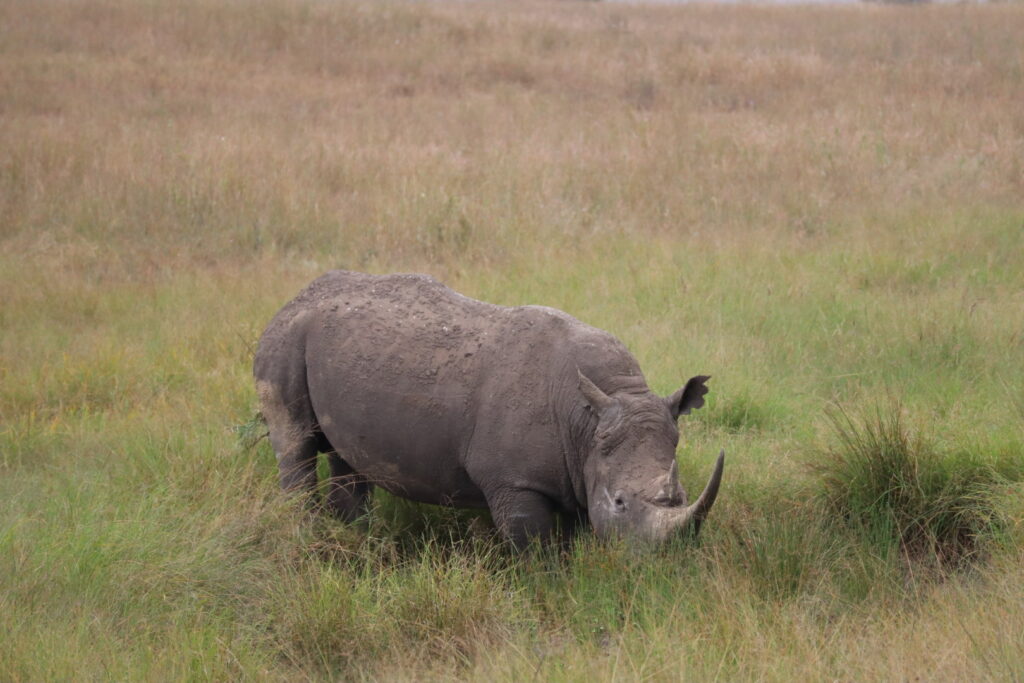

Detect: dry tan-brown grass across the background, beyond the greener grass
0,2,1024,270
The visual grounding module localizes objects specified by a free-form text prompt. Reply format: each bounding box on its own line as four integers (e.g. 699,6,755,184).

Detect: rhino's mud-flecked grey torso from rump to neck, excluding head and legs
282,271,639,506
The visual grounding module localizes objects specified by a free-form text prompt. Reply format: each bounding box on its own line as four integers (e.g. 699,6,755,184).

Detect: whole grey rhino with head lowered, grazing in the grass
254,270,724,548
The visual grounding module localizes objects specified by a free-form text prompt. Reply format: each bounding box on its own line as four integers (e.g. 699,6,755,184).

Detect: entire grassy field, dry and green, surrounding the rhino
0,0,1024,681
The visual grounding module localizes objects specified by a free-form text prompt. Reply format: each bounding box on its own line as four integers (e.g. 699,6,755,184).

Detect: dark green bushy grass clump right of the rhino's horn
813,403,1019,568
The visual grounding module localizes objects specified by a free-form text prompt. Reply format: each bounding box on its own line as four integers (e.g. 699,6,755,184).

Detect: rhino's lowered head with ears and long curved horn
580,372,725,542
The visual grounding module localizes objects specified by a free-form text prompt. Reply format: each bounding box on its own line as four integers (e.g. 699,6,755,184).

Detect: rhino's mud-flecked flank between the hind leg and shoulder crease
305,271,505,506
